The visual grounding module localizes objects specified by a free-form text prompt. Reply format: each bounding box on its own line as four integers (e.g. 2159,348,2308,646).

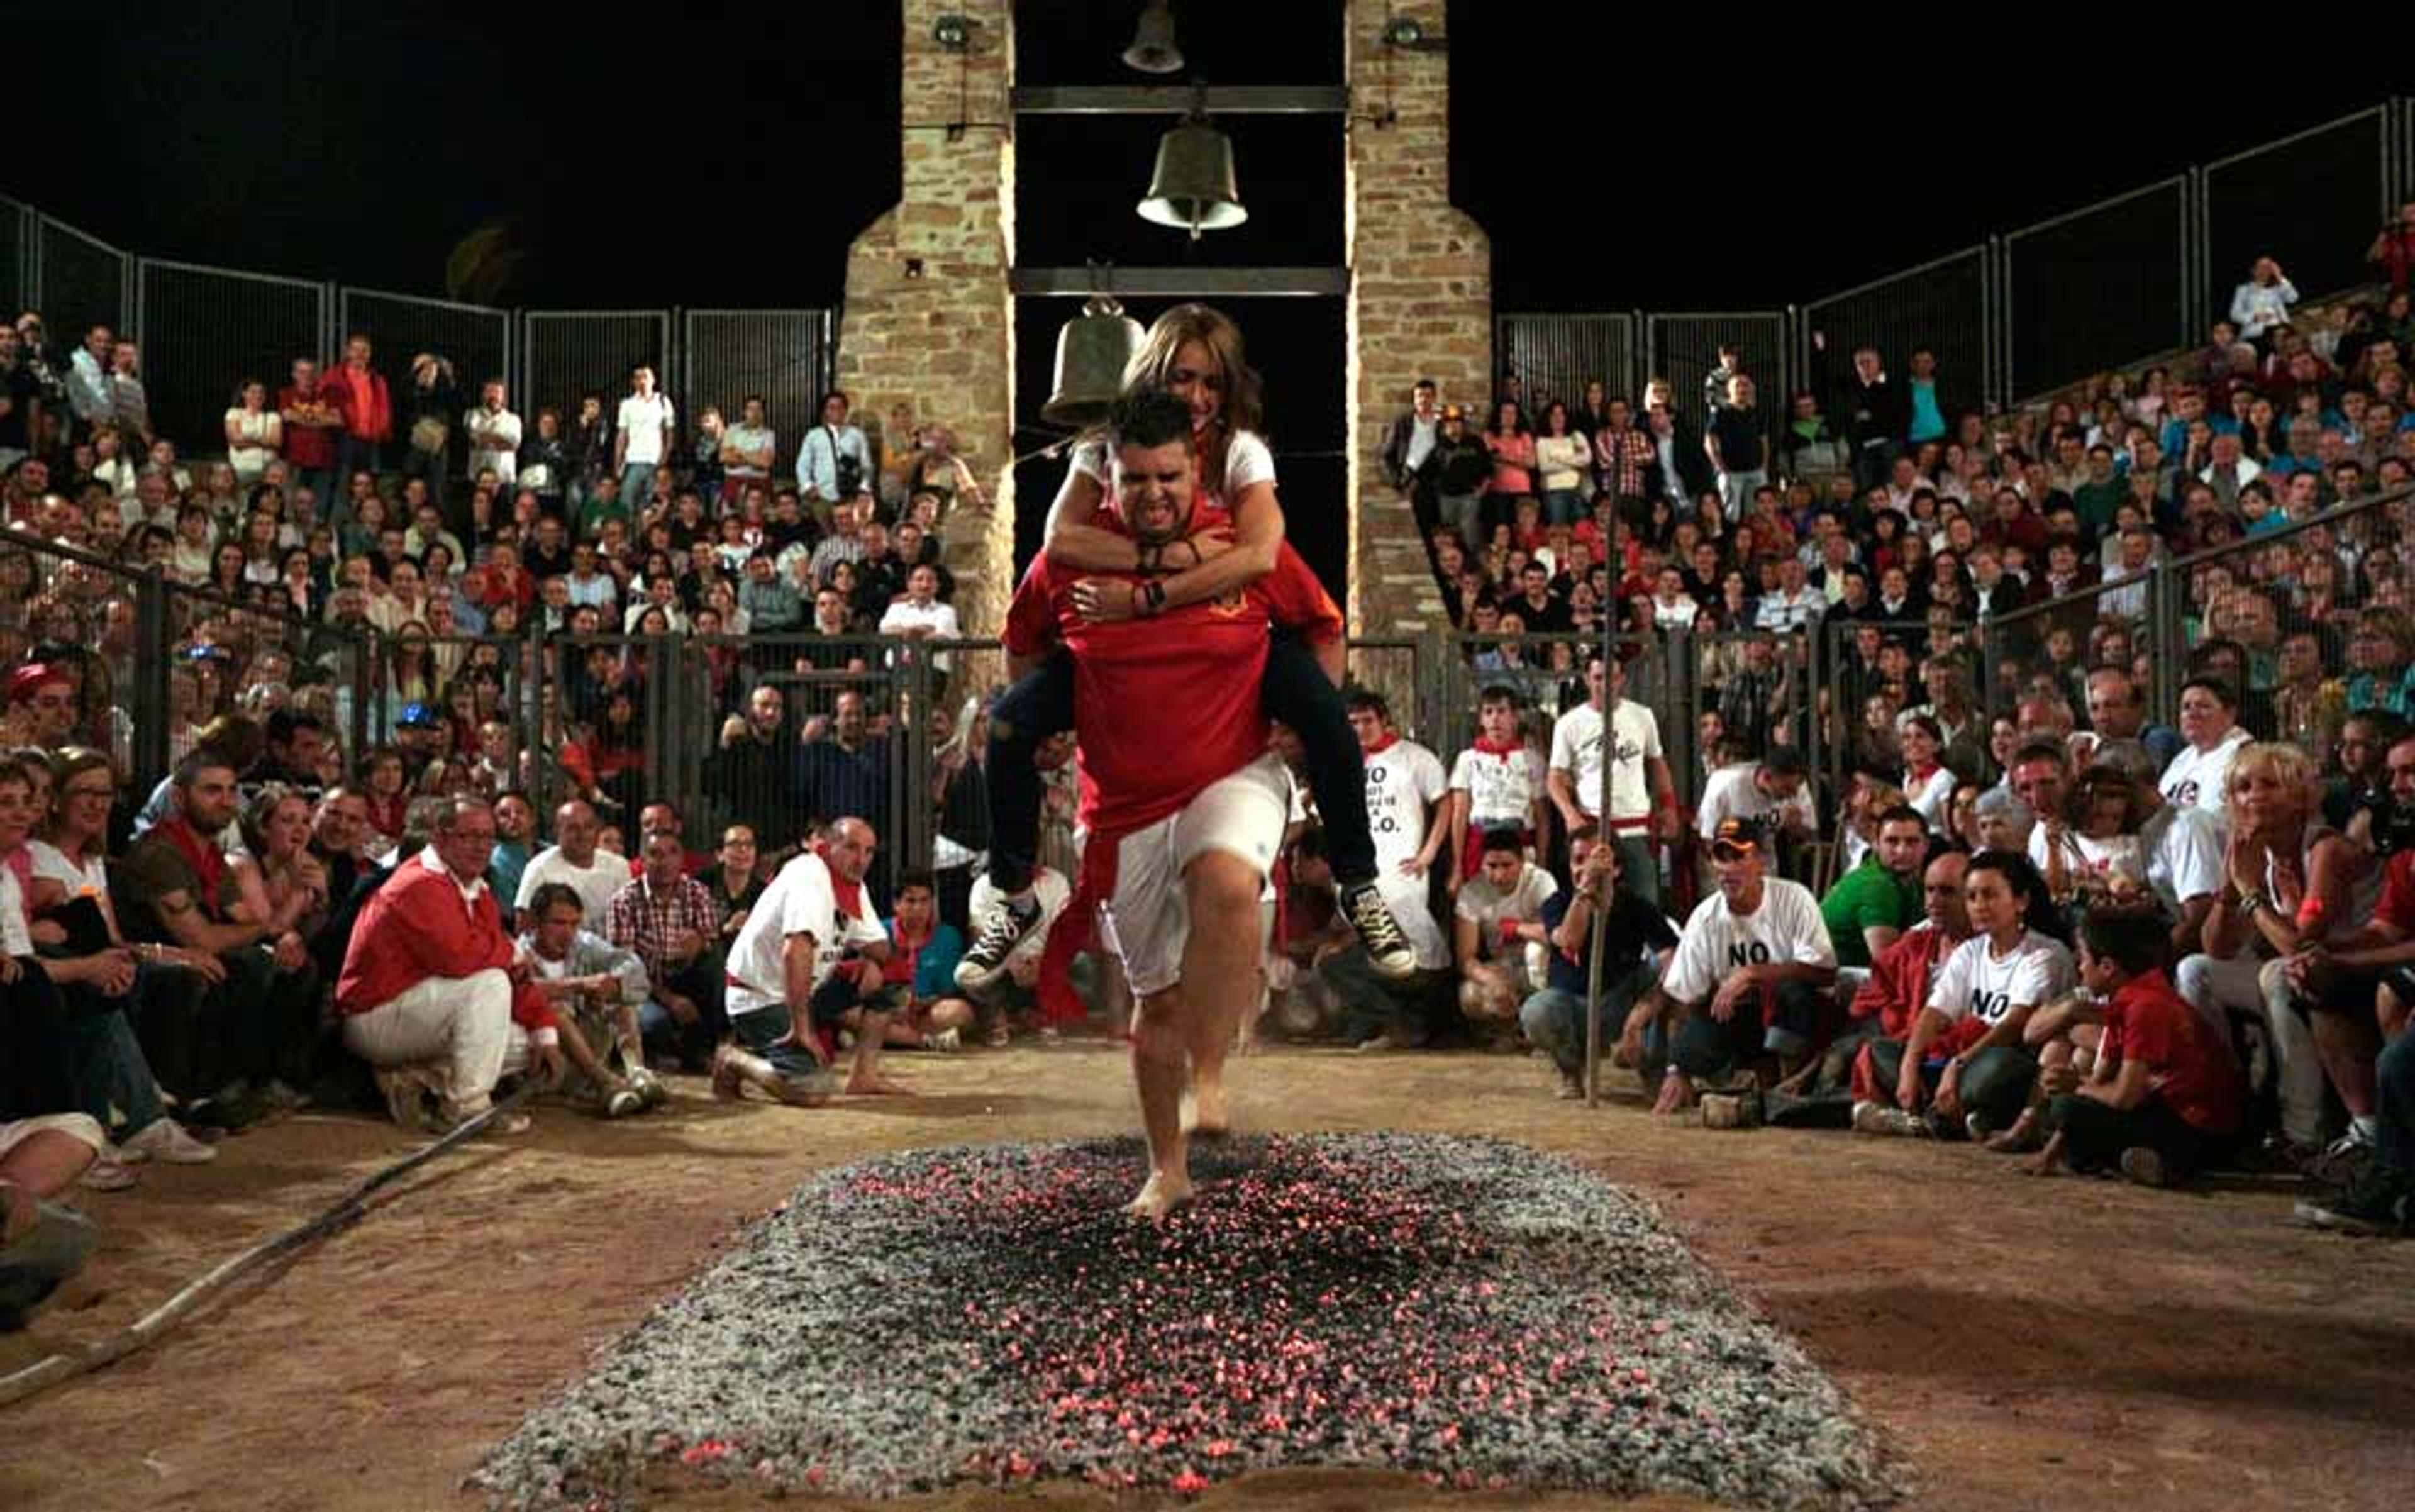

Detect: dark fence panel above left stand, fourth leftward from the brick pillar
133,258,331,452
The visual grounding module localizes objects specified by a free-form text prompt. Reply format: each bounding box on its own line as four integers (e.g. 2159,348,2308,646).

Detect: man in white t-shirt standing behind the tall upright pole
1543,647,1679,903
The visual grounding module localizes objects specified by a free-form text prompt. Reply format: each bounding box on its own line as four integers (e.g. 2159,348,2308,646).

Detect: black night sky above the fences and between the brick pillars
23,0,2415,309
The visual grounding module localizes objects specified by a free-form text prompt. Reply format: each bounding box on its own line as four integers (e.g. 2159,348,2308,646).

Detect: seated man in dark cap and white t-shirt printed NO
1621,819,1835,1113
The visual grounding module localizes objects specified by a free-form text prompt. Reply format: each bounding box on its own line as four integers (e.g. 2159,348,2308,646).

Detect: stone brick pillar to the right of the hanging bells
1345,0,1492,652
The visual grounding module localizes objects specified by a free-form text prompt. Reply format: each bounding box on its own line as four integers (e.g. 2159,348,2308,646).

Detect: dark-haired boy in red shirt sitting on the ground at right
2031,911,2241,1186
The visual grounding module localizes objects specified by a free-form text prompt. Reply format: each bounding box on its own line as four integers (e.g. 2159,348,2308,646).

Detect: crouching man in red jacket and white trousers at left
336,797,563,1128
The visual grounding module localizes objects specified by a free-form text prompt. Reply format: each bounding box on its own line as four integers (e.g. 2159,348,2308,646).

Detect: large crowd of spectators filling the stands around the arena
0,214,2415,1321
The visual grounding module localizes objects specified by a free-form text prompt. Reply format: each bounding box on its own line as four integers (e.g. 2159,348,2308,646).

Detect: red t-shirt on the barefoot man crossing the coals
1004,509,1343,840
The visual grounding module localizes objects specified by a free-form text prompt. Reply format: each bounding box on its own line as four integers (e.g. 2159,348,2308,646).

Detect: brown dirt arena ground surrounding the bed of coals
0,1043,2415,1512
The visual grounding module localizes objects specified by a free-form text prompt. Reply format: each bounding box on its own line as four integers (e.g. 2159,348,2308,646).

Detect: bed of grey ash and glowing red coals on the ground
475,1135,1894,1507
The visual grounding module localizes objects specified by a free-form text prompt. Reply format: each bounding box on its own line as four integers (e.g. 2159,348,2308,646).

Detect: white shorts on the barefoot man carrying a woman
1099,753,1292,998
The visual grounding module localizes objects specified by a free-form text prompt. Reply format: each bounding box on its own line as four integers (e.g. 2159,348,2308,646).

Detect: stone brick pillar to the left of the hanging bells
838,0,1014,684
